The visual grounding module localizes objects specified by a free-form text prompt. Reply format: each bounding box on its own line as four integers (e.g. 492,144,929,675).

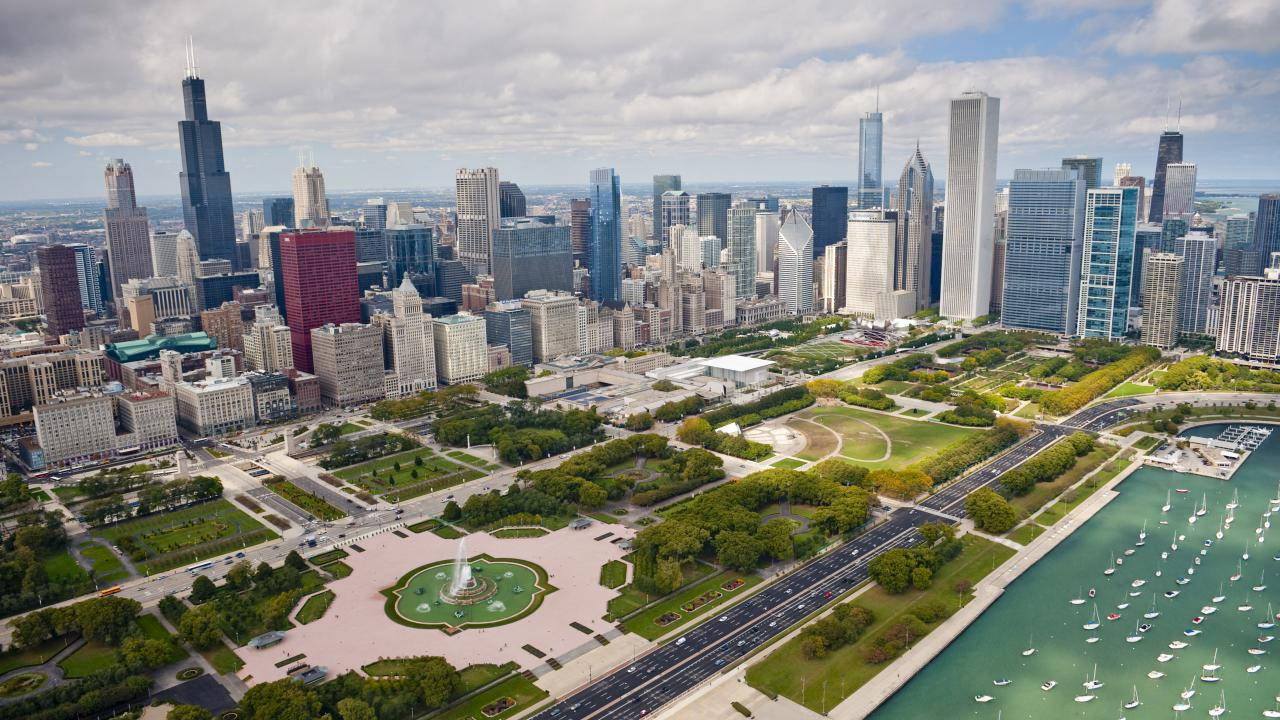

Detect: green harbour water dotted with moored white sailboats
872,428,1280,720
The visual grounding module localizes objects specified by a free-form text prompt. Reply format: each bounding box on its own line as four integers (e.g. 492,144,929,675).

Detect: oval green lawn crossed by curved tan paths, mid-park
787,407,980,468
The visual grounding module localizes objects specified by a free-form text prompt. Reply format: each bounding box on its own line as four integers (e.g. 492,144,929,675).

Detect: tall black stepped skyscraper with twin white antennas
178,49,238,266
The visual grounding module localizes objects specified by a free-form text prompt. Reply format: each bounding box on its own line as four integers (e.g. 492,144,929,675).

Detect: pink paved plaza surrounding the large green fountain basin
236,523,634,683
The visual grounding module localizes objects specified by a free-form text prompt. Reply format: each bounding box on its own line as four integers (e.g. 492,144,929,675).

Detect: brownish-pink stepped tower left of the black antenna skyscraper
102,158,154,308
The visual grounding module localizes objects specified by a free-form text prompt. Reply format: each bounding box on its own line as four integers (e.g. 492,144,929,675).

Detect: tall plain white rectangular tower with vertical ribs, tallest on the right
940,92,1000,320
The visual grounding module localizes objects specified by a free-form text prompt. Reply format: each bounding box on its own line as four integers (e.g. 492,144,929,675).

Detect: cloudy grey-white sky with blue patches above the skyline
0,0,1280,200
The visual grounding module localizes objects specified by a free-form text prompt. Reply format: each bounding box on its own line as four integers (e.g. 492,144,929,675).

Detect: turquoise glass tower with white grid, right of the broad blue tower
1076,187,1138,340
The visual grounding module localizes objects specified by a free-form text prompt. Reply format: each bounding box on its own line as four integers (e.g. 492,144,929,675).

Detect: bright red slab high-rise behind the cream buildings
280,228,360,373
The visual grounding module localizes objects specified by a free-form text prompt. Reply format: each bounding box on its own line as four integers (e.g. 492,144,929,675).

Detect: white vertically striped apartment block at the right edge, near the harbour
1216,266,1280,363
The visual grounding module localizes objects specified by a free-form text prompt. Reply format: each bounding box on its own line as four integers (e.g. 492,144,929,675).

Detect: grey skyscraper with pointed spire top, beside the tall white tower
893,145,933,310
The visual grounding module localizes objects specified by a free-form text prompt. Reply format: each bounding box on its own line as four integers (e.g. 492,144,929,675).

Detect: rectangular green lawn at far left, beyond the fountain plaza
93,500,279,574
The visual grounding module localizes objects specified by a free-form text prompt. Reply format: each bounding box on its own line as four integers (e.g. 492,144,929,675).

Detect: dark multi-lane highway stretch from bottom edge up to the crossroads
524,507,937,720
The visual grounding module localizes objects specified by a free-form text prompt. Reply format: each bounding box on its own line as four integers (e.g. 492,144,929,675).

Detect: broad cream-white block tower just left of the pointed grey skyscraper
844,214,915,320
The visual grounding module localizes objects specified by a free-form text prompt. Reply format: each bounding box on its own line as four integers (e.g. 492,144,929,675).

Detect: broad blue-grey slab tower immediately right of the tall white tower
1000,169,1085,334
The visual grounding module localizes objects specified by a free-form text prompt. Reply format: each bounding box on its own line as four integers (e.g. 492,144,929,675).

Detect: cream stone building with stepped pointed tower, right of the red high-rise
371,274,435,400
